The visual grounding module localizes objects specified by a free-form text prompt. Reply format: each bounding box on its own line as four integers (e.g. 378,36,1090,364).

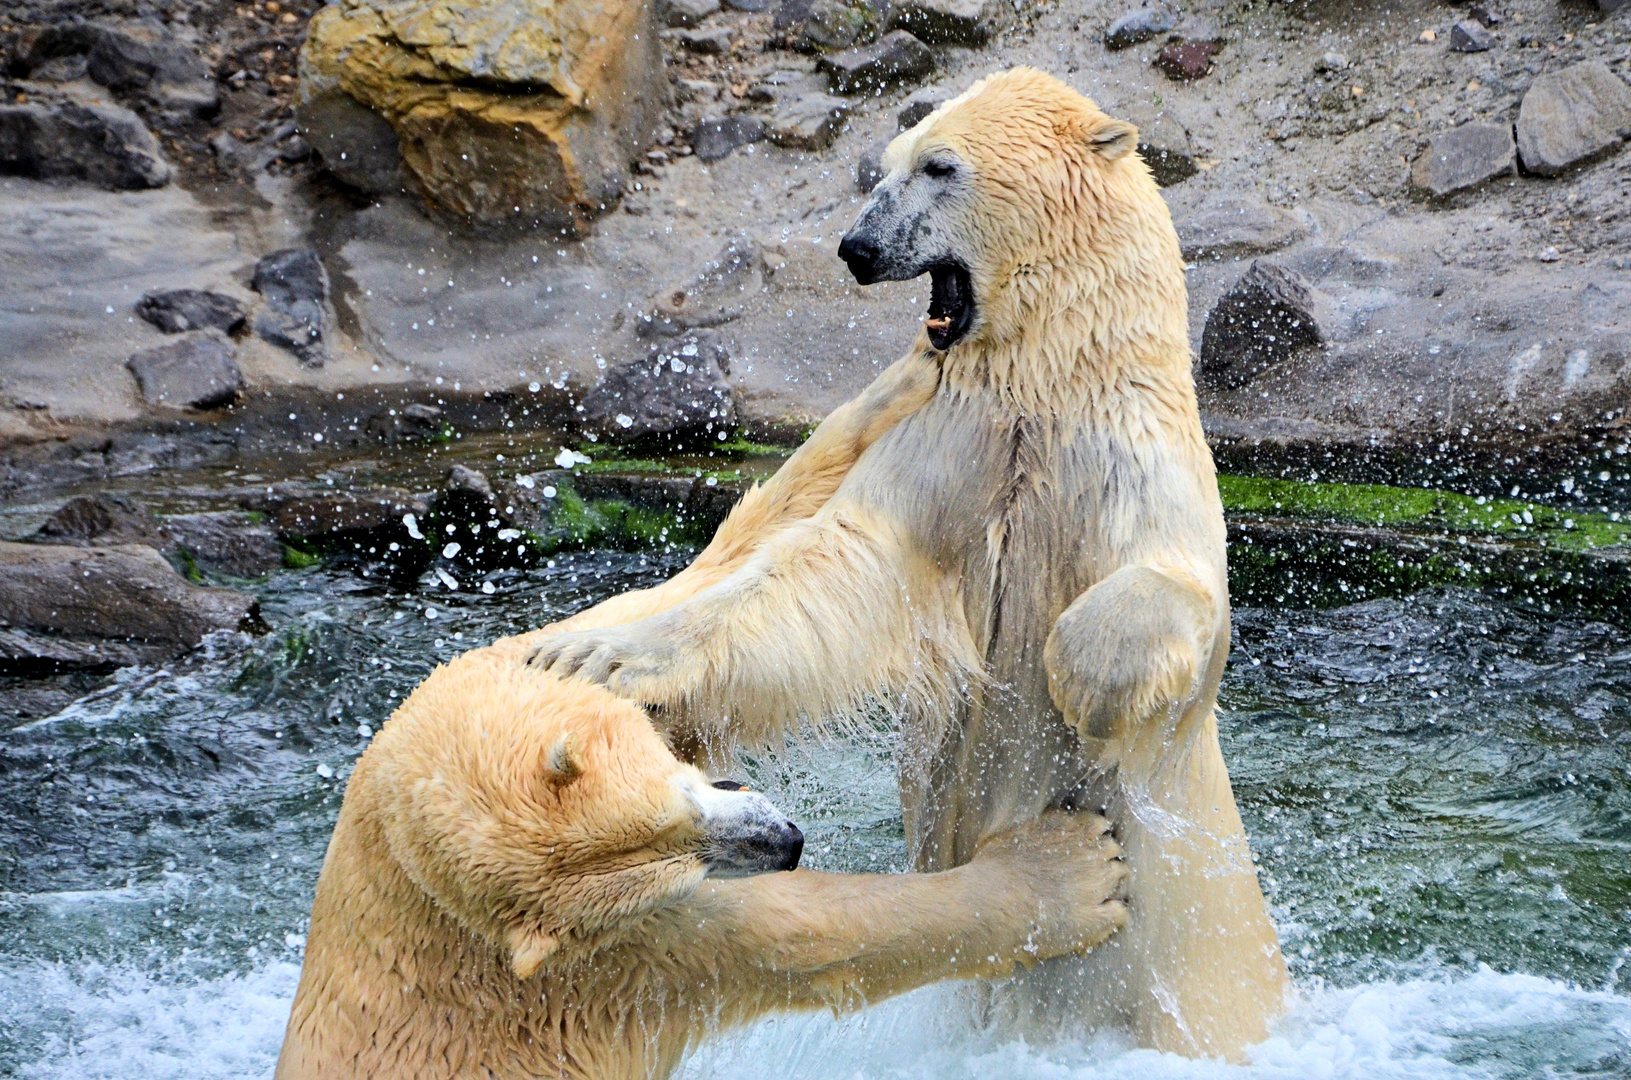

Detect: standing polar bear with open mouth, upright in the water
533,69,1288,1059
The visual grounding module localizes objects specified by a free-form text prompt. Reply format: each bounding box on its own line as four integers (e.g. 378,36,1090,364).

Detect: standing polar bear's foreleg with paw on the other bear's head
532,501,979,744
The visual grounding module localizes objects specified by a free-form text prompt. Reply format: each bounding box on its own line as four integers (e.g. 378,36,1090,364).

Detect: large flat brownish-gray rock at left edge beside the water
0,543,256,656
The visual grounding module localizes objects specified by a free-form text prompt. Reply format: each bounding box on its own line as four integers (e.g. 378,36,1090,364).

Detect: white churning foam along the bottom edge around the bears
0,963,1631,1080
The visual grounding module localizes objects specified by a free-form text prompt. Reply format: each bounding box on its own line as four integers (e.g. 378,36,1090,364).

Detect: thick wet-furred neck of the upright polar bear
944,203,1199,424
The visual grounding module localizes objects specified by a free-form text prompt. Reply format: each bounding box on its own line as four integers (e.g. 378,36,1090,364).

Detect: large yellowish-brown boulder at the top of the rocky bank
297,0,669,235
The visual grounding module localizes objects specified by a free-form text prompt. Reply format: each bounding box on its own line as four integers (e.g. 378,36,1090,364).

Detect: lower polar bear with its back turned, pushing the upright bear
277,359,1125,1080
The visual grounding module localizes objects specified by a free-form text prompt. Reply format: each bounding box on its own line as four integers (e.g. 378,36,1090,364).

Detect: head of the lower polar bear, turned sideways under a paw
366,649,804,977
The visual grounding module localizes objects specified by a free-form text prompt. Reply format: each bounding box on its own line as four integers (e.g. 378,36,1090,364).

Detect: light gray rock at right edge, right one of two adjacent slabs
1517,60,1631,176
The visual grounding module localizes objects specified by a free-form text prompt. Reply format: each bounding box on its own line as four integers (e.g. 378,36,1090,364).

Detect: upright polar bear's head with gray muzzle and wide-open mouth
838,67,1182,351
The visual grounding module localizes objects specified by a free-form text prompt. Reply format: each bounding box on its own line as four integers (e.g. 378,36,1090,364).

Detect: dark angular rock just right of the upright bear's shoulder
1196,259,1331,387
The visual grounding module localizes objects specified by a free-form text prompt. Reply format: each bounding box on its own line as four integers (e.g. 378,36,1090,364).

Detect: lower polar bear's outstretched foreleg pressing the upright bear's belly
687,814,1127,1021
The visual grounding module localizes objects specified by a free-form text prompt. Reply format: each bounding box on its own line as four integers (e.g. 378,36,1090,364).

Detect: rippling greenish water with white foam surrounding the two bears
0,553,1631,1080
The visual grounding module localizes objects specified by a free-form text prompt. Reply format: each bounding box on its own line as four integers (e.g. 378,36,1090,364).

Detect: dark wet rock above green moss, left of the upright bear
582,330,736,447
